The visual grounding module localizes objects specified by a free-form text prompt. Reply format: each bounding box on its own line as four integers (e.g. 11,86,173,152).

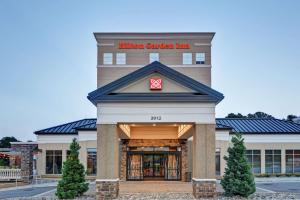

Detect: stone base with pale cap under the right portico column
192,178,217,199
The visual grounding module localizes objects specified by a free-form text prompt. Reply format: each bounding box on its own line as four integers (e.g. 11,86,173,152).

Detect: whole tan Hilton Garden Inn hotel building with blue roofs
35,32,300,199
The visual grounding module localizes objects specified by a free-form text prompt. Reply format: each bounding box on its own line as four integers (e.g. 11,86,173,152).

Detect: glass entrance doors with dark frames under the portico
127,152,181,180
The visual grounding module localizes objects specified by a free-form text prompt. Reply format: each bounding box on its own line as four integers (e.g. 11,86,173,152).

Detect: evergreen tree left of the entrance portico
56,138,88,199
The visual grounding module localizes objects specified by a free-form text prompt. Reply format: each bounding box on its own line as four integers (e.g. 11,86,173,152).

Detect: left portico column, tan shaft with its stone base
96,124,119,200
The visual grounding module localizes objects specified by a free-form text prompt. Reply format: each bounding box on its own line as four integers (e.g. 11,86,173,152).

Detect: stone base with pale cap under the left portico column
96,179,119,200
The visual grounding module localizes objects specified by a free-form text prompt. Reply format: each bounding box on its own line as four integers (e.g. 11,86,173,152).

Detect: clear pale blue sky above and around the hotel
0,0,300,141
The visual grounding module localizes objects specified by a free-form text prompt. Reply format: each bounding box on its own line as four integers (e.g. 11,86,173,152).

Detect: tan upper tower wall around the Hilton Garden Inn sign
96,33,214,87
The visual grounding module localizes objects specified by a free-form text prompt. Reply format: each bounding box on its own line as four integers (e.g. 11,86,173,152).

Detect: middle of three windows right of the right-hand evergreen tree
265,150,281,174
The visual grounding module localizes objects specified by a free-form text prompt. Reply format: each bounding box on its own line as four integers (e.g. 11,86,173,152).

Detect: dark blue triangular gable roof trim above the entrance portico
87,61,224,105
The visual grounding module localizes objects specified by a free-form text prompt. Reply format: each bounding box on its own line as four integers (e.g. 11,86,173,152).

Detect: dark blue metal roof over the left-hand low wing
34,118,97,135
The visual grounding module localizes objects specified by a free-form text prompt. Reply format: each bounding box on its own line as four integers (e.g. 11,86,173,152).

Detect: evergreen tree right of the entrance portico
221,134,255,197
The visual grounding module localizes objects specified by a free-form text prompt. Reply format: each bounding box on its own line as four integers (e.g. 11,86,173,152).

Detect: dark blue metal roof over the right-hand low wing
216,118,300,134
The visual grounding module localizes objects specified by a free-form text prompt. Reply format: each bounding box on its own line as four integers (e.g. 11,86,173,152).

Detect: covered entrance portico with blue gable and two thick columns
88,61,223,199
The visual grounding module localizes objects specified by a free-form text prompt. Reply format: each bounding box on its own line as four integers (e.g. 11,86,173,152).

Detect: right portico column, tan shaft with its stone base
192,124,216,198
